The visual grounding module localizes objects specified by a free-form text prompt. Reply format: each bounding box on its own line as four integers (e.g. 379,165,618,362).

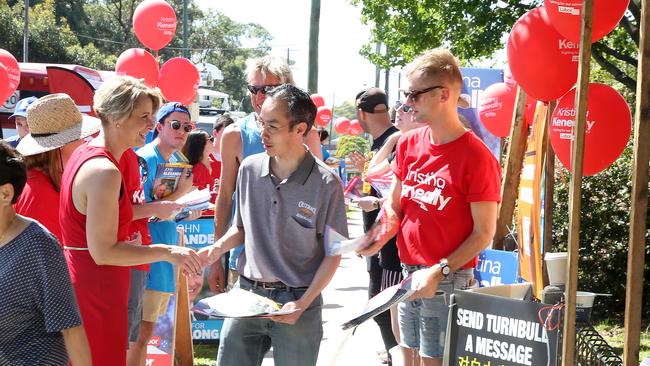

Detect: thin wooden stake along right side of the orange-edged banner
542,100,557,286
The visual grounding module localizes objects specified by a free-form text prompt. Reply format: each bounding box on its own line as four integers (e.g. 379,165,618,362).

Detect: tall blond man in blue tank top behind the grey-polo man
208,56,322,302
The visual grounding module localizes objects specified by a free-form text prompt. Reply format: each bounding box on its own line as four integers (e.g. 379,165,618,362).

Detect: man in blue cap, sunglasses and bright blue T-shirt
130,103,200,363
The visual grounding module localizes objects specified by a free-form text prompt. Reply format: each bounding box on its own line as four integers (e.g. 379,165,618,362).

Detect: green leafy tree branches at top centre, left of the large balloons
350,0,536,68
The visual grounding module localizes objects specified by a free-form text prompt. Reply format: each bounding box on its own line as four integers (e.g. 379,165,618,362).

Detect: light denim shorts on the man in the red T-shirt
397,265,475,358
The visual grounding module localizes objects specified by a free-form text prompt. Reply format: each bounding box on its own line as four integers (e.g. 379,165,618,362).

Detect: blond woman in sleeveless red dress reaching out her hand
60,76,201,366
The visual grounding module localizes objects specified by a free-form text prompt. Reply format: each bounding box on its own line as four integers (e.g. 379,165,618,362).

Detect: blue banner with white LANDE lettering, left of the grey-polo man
179,216,223,343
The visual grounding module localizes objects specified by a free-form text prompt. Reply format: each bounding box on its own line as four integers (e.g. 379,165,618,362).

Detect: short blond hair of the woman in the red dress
93,76,162,126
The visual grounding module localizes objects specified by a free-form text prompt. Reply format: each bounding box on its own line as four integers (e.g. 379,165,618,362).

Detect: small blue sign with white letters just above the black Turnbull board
474,249,519,287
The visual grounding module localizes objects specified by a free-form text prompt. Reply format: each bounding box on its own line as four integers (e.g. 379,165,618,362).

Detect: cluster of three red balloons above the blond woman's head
115,0,201,104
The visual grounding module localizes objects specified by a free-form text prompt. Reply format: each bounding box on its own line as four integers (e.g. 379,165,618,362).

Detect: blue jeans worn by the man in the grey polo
217,278,323,366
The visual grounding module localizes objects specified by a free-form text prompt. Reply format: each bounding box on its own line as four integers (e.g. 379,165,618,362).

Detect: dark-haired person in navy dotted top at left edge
0,140,90,366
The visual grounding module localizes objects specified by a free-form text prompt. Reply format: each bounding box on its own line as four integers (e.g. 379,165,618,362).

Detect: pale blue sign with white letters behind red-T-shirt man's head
458,67,503,159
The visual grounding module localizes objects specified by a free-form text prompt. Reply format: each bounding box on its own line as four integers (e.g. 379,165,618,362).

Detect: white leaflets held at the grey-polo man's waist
192,288,300,318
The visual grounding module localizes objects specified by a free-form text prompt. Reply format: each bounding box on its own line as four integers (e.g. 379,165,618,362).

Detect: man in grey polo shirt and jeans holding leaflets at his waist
199,84,347,366
